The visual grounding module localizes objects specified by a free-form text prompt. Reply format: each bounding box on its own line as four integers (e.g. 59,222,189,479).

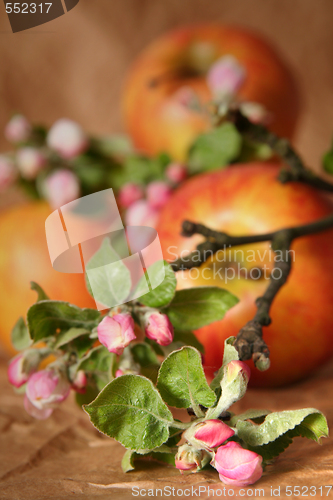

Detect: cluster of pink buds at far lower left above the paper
8,349,87,420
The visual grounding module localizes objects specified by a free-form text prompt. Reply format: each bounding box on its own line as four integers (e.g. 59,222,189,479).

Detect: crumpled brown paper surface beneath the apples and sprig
0,361,333,500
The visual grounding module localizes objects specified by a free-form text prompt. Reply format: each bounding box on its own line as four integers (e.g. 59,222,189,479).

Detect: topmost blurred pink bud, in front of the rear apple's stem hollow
207,55,246,96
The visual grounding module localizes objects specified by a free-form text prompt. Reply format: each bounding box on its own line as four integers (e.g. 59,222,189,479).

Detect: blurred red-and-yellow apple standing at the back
123,25,300,161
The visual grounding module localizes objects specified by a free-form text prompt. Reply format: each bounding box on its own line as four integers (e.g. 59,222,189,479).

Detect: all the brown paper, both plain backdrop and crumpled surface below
0,0,333,500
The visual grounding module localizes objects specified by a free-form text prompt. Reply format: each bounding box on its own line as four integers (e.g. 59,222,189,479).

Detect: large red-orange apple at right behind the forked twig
157,163,333,387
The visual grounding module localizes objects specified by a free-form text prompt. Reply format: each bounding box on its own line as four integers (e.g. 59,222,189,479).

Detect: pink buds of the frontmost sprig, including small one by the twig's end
175,361,262,486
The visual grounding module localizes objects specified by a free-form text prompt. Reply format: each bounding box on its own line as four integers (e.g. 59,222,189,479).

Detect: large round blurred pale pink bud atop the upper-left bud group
47,118,89,159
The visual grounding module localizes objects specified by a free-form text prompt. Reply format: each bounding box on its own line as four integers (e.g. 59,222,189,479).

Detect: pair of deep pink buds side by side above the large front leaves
97,308,174,358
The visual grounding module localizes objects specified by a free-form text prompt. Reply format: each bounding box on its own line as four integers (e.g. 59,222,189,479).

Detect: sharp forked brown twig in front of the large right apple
171,214,333,370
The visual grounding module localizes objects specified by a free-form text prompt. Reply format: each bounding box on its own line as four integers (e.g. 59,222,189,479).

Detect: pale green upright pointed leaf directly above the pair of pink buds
86,238,131,307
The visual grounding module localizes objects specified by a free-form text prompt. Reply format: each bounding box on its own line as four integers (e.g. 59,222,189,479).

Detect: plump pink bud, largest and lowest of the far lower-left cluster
25,369,70,419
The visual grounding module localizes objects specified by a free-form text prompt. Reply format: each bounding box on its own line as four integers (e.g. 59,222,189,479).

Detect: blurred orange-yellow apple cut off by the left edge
0,201,96,355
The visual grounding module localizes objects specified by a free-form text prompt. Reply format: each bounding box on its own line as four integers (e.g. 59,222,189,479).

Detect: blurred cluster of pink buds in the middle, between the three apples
118,163,187,227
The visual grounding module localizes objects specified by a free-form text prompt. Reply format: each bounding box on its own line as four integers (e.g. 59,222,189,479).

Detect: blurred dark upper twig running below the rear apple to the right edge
216,106,333,192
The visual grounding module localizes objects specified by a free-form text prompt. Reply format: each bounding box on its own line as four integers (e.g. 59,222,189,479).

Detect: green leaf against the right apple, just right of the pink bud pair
164,286,238,330
